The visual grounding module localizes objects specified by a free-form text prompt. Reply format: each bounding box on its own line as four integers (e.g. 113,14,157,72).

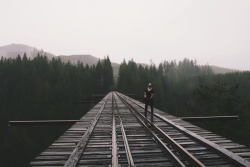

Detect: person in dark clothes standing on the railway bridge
144,83,154,122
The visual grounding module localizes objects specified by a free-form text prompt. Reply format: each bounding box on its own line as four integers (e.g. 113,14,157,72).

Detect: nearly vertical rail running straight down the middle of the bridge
112,93,118,167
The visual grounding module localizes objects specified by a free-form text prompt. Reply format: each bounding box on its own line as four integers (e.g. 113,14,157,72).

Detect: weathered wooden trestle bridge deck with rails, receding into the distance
29,92,250,167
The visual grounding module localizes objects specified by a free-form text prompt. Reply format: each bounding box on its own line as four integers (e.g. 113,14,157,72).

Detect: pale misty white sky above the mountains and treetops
0,0,250,70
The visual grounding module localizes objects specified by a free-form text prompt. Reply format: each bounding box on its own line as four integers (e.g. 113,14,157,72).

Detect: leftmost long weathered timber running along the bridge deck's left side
64,95,109,167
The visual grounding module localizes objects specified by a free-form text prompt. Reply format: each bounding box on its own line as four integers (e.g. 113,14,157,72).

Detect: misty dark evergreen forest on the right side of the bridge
117,59,250,149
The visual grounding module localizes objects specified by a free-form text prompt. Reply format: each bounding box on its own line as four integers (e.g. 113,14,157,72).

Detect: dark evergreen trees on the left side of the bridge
0,53,113,166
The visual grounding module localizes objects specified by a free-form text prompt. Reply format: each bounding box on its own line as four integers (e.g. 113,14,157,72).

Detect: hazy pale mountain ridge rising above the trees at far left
0,44,54,59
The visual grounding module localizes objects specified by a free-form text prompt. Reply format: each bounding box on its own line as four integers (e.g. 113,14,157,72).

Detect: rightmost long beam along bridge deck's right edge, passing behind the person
121,92,250,166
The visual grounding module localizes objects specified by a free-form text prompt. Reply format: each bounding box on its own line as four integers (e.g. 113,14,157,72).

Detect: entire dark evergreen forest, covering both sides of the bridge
0,54,250,167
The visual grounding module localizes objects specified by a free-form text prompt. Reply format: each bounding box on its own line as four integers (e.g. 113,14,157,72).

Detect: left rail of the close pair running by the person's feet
117,94,186,167
